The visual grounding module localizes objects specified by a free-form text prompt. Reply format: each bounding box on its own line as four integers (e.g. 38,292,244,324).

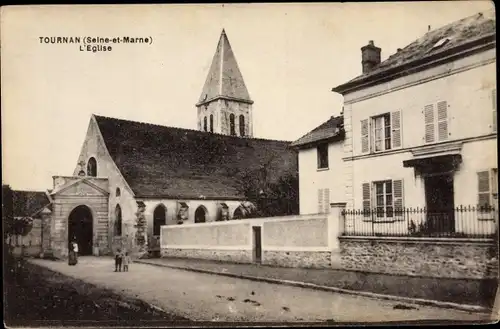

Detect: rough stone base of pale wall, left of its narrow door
161,248,252,263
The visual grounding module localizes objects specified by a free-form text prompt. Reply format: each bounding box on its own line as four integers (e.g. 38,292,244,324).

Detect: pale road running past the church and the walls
30,257,489,322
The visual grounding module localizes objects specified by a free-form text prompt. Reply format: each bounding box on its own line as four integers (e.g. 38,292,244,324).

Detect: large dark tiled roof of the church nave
95,116,297,199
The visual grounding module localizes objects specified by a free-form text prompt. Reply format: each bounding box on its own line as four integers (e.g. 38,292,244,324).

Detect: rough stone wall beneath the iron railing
339,237,498,279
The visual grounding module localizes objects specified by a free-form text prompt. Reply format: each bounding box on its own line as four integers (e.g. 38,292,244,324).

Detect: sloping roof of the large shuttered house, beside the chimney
332,11,496,93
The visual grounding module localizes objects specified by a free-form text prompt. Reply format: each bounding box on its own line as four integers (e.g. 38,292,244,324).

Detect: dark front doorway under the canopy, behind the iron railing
425,174,455,234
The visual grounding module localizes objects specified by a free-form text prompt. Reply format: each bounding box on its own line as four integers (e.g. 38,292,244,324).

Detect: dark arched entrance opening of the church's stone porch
68,205,94,256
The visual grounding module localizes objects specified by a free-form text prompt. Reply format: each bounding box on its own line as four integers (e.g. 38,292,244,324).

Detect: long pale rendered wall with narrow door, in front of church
161,215,334,268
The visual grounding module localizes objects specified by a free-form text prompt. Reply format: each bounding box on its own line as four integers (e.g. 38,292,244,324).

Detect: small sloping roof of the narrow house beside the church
291,116,344,148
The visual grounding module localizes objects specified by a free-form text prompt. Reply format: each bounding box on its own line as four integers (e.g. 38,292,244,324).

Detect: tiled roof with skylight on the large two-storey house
333,11,496,92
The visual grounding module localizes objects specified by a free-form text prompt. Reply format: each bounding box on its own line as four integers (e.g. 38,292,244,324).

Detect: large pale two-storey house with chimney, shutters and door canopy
333,11,498,234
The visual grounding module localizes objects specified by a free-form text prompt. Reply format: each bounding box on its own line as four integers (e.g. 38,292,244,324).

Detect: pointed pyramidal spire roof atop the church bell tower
197,30,253,105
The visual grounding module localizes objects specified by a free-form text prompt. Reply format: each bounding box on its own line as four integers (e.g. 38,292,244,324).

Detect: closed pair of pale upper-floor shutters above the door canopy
423,101,449,143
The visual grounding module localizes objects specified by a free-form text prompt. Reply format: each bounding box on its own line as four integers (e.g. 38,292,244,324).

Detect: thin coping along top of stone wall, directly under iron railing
339,235,495,244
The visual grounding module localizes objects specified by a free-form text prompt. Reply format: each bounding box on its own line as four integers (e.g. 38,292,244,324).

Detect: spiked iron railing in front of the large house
342,206,498,238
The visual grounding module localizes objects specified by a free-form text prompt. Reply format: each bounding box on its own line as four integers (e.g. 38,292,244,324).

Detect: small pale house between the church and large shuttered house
291,115,345,214
